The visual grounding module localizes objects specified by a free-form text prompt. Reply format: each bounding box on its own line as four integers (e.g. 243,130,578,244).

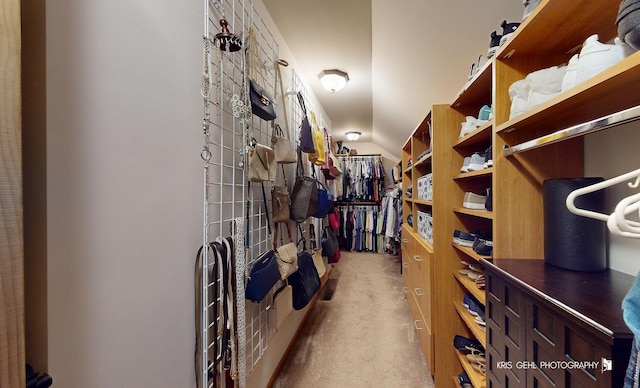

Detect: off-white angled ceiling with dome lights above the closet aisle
263,0,524,161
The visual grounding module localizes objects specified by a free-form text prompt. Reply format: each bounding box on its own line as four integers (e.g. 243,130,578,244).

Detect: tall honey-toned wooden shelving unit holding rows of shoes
402,0,640,387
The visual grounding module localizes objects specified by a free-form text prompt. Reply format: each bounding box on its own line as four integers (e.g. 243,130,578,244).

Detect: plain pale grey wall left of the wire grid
47,0,202,387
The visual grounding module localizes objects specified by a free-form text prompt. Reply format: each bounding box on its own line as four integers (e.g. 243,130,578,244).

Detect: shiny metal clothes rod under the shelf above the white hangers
503,105,640,156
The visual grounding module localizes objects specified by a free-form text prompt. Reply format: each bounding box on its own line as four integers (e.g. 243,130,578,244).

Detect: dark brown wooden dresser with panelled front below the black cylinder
481,259,634,387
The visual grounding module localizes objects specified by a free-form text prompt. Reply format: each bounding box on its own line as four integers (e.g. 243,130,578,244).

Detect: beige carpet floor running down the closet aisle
274,252,434,388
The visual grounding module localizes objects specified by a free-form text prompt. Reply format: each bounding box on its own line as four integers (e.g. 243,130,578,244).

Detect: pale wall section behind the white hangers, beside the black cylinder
584,123,640,276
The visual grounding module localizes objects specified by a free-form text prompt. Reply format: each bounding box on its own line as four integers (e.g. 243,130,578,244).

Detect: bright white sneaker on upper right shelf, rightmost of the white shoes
576,34,625,85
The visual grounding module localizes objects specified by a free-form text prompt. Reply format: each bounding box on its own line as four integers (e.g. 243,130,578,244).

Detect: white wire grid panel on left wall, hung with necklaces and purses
196,0,278,387
